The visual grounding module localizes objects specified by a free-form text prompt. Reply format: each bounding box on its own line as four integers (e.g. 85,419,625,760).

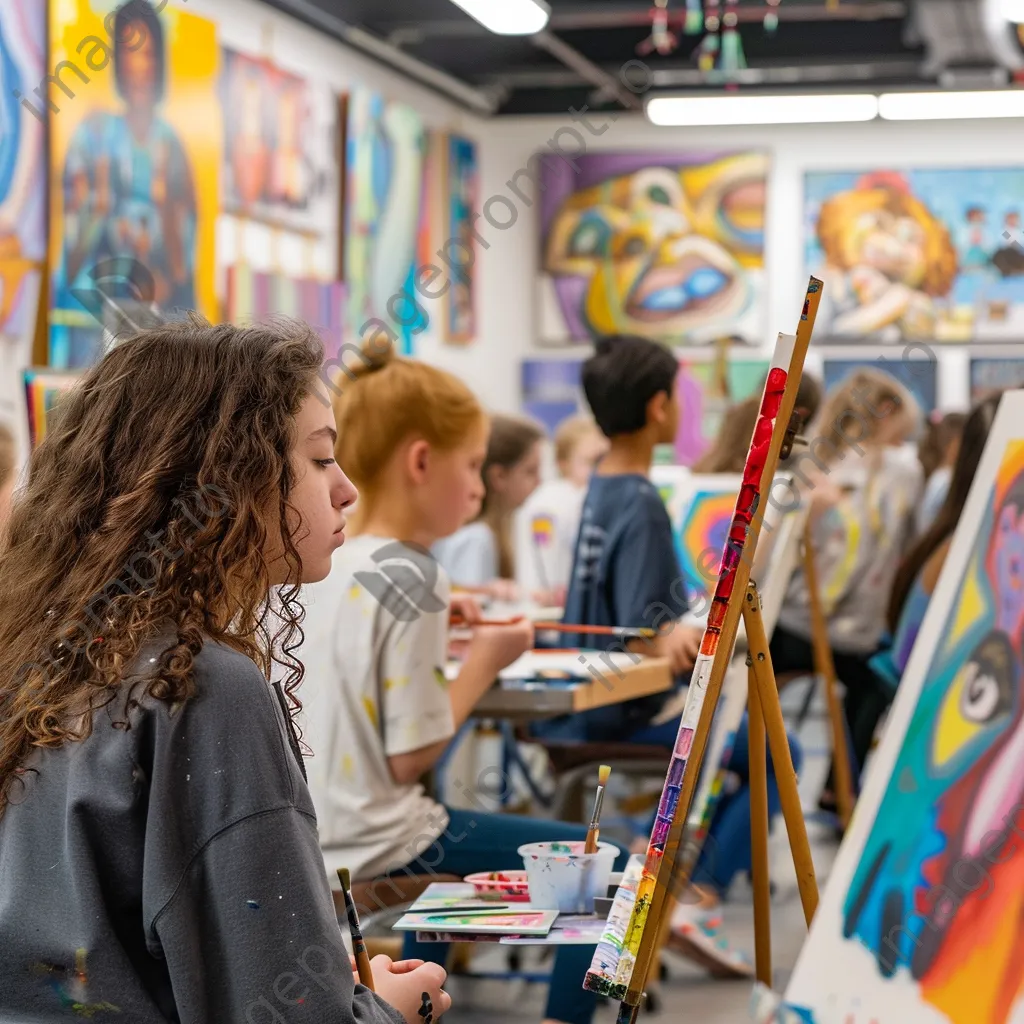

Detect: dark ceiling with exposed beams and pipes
258,0,1024,115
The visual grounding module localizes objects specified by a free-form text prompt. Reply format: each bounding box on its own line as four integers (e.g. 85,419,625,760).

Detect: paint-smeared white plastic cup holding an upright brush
519,842,618,913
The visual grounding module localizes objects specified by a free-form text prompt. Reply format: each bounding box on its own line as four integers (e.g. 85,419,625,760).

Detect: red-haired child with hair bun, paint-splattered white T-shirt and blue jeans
303,350,628,1024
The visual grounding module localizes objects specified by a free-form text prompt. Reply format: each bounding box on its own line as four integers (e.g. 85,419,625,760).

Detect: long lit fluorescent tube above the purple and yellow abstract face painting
646,93,879,127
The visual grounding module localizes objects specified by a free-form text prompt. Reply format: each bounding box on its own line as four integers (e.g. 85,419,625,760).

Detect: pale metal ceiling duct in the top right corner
913,0,1024,80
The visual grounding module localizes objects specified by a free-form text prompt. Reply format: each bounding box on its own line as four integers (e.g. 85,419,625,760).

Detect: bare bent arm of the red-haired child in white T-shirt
385,621,534,785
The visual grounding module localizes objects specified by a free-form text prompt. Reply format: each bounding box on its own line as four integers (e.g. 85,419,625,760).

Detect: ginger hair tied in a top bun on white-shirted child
334,346,486,514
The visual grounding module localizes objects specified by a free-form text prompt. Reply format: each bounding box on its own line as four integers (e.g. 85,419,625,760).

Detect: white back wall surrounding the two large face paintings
461,114,1024,410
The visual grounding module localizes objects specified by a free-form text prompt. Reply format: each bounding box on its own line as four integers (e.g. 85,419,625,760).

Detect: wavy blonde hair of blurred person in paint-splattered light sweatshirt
812,367,921,458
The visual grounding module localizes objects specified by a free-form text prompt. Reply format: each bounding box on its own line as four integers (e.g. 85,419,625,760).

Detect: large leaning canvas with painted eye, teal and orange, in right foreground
785,393,1024,1024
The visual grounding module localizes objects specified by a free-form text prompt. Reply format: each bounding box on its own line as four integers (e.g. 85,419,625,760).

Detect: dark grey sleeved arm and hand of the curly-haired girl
154,802,450,1024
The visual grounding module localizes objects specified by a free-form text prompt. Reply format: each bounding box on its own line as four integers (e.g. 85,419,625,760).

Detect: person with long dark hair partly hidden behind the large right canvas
871,394,1001,689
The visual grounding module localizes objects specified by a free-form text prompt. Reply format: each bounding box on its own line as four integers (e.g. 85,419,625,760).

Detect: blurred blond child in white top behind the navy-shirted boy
515,416,608,606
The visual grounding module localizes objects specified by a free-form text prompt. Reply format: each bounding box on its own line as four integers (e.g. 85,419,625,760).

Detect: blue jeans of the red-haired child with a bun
401,808,629,1024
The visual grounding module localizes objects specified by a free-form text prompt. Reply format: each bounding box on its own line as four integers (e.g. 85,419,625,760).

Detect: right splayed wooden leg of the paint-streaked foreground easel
743,584,818,927
